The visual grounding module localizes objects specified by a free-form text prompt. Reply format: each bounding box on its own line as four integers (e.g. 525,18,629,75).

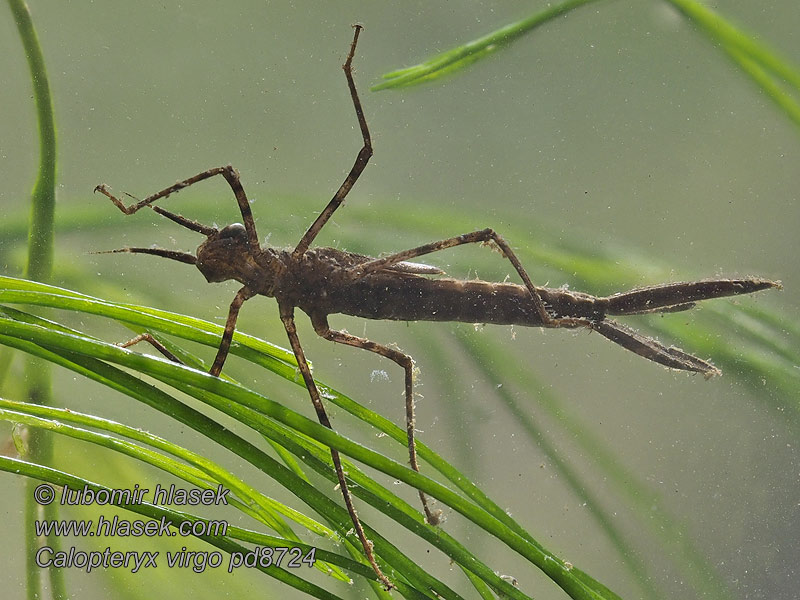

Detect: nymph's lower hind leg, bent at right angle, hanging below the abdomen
311,313,441,525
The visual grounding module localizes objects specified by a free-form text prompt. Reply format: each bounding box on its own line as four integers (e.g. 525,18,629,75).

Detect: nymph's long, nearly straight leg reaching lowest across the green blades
278,302,394,590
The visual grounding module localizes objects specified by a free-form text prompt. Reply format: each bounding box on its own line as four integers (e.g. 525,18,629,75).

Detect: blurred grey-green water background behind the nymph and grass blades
0,0,800,599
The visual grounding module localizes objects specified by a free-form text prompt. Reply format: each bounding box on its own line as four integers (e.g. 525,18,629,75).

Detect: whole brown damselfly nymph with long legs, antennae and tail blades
95,25,780,588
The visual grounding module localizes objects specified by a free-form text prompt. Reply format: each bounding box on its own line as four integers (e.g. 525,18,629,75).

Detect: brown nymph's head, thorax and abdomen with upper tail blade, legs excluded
196,232,775,327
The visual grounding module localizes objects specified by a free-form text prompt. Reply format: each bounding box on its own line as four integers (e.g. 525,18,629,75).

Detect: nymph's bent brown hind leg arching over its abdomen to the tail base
354,229,592,327
